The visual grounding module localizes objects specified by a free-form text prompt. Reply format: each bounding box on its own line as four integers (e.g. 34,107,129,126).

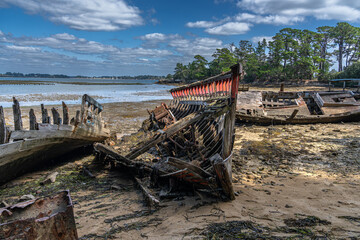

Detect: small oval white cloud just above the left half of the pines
205,22,251,35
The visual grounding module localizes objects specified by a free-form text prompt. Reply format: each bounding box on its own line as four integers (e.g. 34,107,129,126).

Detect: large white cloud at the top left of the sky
3,0,143,31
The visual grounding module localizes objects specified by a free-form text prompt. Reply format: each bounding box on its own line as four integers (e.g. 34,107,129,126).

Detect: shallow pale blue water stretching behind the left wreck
0,78,171,107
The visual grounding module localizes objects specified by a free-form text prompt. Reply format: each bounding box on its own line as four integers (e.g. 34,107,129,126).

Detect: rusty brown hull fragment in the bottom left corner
0,191,78,240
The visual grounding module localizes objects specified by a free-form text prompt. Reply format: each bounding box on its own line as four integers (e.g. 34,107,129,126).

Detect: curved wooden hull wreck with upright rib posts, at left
0,94,110,184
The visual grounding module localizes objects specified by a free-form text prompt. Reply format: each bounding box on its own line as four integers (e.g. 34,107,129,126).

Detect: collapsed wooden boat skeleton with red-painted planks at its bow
95,65,242,202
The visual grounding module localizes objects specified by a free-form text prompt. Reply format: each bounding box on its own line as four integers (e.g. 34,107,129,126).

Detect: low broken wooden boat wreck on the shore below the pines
236,91,360,125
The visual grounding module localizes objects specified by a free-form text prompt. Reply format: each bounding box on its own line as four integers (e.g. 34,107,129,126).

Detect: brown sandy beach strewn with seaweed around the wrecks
0,89,360,239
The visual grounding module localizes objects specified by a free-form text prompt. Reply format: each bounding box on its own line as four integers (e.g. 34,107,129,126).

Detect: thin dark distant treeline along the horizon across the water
0,72,165,80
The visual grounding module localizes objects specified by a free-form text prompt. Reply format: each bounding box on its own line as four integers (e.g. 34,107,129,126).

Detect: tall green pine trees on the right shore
173,22,360,82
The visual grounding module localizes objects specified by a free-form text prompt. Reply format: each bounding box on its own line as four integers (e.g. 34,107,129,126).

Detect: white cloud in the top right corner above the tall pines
237,0,360,21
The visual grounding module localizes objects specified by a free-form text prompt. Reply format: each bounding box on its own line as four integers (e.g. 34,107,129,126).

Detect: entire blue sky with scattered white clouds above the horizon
0,0,360,76
